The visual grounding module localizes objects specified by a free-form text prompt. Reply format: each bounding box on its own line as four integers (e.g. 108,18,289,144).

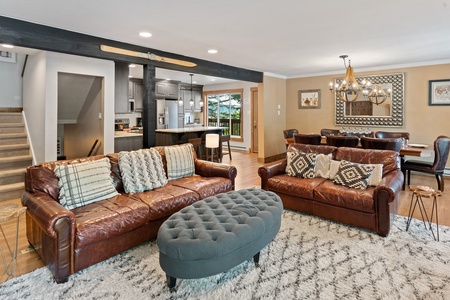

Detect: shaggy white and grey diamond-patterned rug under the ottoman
0,211,450,300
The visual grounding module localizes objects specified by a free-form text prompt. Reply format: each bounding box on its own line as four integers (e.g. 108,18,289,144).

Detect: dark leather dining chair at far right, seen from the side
402,135,450,192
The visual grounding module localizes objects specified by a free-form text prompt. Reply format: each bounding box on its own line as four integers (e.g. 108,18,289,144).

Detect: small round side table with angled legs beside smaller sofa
406,185,442,241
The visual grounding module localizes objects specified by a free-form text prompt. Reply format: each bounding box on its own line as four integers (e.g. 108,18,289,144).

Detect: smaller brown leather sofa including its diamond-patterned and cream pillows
258,144,404,236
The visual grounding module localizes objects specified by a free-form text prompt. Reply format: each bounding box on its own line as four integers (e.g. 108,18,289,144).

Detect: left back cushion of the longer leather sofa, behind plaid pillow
25,155,105,200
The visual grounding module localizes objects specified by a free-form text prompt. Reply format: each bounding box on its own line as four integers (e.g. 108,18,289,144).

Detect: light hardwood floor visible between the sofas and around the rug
0,151,450,283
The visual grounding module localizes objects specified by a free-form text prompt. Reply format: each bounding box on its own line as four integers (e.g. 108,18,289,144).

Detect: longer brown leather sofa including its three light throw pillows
22,144,237,283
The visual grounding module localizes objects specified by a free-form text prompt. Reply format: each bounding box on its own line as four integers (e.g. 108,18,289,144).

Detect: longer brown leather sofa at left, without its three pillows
22,147,237,283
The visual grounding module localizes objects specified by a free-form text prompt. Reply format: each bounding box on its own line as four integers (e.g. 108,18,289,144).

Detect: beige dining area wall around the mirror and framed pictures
286,64,450,149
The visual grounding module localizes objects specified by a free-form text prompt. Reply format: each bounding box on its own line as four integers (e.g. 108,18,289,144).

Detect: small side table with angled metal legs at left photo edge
0,203,27,276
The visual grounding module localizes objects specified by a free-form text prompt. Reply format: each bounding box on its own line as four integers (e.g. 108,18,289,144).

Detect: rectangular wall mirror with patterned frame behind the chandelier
334,73,404,127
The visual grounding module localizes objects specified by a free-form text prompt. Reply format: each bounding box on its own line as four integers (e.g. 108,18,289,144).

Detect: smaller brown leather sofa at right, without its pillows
258,144,403,236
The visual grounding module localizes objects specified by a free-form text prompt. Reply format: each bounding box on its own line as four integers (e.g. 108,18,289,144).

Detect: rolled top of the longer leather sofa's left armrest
22,191,75,241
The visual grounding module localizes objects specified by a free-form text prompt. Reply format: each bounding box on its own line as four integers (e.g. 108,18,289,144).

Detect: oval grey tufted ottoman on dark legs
157,188,283,289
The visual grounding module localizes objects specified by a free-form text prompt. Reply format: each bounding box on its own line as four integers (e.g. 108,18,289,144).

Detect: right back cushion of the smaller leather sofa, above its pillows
335,147,399,176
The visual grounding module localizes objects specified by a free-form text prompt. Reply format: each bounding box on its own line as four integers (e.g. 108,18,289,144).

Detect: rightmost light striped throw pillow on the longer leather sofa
164,144,195,180
